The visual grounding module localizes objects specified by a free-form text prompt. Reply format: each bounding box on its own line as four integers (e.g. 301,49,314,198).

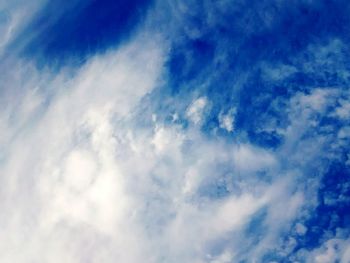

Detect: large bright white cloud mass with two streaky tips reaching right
0,45,296,262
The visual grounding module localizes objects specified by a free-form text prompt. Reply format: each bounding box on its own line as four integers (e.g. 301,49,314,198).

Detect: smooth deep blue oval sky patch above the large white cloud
16,0,152,63
